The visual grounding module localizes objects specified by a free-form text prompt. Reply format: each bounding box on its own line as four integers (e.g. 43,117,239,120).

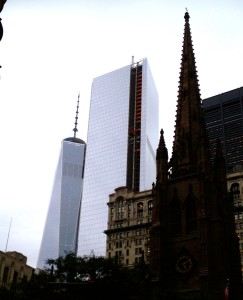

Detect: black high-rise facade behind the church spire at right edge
202,87,243,173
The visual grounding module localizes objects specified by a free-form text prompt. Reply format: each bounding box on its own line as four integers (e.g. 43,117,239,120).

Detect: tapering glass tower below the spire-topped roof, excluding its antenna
37,137,86,269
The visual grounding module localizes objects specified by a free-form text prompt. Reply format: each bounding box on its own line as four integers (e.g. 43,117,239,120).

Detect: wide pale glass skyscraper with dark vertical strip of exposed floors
78,58,159,256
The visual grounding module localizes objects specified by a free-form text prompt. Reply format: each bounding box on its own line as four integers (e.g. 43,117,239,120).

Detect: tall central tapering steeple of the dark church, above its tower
170,12,211,176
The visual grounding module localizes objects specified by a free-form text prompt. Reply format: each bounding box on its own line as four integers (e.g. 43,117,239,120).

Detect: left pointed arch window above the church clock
170,199,181,235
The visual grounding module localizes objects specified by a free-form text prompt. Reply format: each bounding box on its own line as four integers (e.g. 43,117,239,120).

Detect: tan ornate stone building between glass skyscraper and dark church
105,187,153,266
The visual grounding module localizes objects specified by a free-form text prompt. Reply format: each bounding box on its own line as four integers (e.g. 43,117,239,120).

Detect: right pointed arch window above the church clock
185,197,197,233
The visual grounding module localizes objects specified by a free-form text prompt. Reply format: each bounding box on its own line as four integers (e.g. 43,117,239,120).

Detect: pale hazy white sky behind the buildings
0,0,243,267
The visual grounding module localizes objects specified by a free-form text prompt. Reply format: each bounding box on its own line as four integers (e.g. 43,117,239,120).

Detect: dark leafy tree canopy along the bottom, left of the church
5,253,150,300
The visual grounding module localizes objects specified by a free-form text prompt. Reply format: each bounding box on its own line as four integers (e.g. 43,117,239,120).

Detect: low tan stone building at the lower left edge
0,251,34,289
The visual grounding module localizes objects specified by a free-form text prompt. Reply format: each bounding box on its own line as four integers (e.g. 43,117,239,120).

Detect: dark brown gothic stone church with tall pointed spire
150,12,241,300
